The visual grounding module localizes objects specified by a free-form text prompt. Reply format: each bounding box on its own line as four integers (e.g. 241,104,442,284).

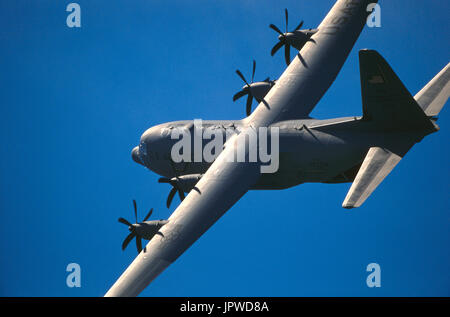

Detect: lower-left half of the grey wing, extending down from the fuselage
105,134,260,296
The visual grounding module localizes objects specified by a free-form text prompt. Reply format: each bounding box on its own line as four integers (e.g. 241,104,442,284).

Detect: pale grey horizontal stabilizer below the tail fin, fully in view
342,147,402,209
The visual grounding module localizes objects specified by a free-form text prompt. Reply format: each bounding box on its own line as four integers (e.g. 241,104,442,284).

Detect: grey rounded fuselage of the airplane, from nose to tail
132,117,417,189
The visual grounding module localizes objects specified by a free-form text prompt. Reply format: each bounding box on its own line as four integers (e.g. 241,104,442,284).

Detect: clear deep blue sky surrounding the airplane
0,0,450,296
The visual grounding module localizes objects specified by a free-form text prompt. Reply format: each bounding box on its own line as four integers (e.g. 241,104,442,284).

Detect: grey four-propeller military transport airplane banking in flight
105,0,450,296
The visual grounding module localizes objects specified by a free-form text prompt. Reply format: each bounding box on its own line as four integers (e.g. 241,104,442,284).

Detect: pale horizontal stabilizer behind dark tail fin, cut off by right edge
414,63,450,117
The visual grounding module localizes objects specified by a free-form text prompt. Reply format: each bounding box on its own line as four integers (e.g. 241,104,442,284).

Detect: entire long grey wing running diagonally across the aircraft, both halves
106,0,376,296
